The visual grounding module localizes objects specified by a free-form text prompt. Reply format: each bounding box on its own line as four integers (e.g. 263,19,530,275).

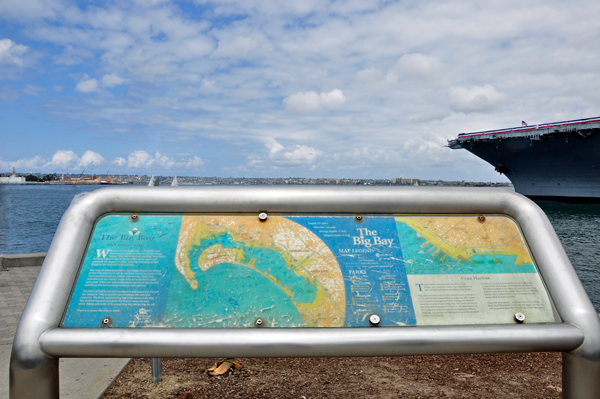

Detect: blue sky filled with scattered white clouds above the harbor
0,0,600,181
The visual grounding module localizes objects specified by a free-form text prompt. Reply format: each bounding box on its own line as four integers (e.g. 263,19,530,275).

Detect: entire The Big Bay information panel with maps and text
62,214,555,328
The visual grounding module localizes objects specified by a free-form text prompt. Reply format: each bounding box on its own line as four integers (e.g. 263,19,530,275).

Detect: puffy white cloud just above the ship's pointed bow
448,84,504,113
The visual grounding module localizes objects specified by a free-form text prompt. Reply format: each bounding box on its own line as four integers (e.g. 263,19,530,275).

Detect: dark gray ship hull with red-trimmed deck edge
448,117,600,203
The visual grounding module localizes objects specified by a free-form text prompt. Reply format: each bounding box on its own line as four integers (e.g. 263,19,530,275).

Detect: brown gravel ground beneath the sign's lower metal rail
102,353,561,399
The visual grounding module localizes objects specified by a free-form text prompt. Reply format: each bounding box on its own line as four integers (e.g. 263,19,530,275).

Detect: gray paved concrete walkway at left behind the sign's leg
0,262,130,399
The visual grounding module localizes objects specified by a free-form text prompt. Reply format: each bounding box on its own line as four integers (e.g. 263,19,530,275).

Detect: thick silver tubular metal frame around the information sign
10,186,600,399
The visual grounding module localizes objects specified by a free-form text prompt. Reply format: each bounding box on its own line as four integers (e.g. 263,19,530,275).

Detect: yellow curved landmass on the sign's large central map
175,215,346,327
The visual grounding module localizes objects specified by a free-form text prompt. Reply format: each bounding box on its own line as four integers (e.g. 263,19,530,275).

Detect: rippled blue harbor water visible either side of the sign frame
0,185,600,312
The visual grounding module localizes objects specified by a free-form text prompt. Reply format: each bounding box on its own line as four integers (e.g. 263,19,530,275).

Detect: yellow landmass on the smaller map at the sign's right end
396,216,533,264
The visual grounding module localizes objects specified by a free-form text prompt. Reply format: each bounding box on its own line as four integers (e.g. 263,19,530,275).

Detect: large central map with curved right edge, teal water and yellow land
164,216,346,327
